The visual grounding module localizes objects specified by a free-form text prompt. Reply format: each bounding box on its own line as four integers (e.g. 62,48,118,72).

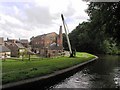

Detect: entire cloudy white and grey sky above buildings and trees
0,0,89,39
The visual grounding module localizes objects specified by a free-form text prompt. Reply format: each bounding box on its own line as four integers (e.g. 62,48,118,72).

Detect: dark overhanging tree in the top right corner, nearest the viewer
87,2,120,43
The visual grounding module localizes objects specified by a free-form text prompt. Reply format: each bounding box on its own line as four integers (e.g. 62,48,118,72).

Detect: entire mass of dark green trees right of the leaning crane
64,0,120,54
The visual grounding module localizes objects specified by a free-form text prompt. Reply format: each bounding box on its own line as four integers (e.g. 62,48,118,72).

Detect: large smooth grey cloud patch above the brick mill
25,7,54,27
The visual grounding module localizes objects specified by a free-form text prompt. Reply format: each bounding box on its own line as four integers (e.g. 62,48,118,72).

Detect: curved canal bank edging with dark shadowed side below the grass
2,56,98,89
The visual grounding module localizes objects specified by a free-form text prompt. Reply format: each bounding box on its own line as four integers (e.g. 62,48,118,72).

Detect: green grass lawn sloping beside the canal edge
2,53,95,84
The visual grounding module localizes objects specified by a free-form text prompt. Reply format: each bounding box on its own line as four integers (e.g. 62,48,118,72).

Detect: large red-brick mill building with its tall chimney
30,26,63,56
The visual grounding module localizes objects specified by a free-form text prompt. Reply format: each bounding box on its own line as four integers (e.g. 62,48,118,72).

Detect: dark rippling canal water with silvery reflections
49,55,120,90
